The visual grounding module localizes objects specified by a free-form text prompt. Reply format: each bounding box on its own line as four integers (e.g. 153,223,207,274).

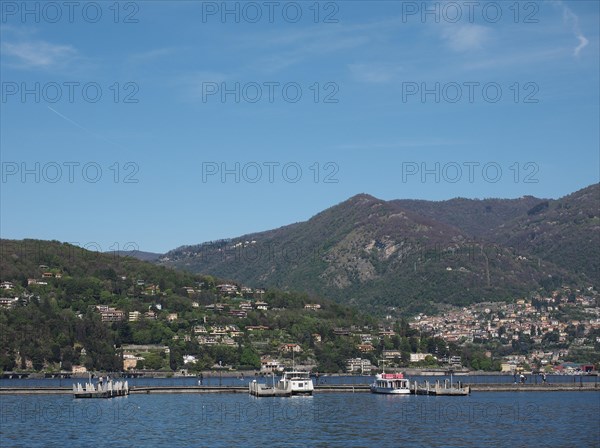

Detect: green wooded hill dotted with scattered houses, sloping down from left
0,240,374,371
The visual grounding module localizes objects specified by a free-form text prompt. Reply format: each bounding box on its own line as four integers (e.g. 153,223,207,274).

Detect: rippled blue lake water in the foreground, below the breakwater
0,392,600,447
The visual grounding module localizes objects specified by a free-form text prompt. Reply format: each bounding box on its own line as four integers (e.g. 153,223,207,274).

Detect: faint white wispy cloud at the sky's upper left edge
0,41,77,69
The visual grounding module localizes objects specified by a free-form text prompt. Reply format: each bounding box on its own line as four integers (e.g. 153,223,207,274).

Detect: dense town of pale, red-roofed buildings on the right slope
410,287,600,372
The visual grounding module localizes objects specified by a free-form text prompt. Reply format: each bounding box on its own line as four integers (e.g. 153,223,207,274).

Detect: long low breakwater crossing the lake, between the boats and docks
0,383,600,395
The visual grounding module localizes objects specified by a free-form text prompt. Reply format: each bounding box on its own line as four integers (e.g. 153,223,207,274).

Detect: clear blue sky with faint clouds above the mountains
0,1,600,252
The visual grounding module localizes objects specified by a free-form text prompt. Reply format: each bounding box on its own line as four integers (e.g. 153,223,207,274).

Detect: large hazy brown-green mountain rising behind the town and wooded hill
160,185,600,310
